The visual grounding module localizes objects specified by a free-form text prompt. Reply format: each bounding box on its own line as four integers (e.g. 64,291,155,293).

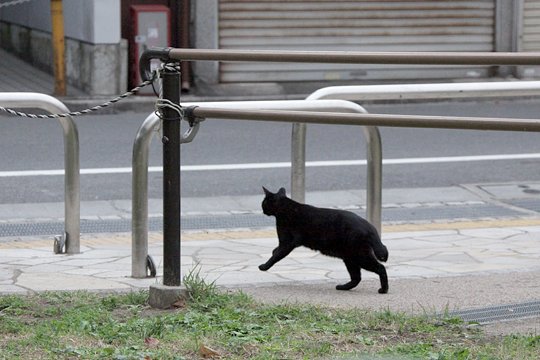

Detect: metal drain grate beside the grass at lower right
448,300,540,324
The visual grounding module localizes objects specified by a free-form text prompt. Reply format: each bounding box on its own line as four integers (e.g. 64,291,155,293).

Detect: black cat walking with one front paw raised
259,187,388,294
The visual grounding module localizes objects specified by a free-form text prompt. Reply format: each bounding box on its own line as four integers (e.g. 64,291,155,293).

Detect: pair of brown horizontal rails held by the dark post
139,48,540,288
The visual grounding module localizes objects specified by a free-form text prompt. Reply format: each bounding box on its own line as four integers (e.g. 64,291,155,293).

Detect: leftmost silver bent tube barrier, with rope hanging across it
0,92,81,254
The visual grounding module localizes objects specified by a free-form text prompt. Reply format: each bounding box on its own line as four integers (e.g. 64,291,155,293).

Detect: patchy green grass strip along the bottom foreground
0,272,540,359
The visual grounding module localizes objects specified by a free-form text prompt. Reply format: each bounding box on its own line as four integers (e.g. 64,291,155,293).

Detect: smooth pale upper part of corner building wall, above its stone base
0,0,121,44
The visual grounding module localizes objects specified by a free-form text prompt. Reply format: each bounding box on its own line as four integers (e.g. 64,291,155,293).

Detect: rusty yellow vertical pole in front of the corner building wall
51,0,66,96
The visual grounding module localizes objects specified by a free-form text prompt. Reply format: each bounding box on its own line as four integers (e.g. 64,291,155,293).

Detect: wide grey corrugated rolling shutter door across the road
219,0,495,82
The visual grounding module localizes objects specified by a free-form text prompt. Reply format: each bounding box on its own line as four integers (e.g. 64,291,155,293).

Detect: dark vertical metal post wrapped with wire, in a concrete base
162,66,181,286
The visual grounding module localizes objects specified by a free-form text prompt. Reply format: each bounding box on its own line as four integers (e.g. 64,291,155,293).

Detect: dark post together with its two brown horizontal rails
139,48,540,286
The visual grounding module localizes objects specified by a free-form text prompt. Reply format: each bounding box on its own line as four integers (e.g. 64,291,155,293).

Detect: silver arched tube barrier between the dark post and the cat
131,100,382,278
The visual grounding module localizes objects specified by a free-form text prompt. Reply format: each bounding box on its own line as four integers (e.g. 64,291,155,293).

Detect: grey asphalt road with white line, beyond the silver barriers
0,100,540,204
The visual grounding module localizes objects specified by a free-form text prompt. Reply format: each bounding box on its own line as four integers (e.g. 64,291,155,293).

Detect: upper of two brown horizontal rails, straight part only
169,49,540,65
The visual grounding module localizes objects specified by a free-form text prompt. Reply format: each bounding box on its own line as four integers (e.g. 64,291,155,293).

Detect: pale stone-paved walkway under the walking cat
0,219,540,309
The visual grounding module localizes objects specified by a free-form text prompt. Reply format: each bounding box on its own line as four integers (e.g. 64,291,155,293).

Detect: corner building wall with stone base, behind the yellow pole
0,0,127,95
